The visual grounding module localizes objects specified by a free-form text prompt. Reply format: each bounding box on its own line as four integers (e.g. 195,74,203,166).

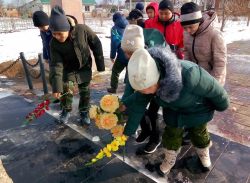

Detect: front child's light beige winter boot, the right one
195,141,212,168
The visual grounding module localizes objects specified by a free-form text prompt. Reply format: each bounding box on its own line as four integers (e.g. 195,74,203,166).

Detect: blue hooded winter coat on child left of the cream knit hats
110,16,128,65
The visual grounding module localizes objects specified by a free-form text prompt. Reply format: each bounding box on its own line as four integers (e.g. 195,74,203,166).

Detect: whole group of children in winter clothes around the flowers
33,0,229,175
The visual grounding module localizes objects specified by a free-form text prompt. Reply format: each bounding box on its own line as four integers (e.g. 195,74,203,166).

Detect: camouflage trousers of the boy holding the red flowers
61,81,90,112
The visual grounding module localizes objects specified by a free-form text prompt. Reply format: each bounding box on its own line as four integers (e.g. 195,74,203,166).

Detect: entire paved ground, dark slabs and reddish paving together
0,41,250,183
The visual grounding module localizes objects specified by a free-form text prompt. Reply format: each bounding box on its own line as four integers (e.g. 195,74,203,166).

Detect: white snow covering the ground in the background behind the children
0,20,250,63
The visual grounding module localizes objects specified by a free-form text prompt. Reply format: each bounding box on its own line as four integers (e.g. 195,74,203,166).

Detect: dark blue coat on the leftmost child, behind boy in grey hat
40,30,52,63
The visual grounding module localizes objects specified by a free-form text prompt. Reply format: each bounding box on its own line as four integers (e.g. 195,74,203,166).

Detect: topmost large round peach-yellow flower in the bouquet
100,95,119,113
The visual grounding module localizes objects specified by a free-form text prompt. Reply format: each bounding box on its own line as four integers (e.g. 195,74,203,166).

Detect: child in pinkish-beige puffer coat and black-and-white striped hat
181,2,227,85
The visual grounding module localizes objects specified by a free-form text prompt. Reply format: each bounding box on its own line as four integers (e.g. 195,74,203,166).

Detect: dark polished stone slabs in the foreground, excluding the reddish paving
0,91,250,183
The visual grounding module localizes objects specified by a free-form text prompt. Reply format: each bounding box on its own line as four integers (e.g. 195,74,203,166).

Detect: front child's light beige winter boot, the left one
159,149,180,176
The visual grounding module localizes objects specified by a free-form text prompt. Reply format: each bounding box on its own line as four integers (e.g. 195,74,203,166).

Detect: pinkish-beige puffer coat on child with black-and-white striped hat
184,12,227,85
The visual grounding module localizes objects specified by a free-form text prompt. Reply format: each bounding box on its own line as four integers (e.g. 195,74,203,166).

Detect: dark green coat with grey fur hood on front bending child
122,47,229,135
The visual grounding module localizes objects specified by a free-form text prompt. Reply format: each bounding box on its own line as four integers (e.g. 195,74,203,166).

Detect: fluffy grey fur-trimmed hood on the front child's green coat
148,47,182,103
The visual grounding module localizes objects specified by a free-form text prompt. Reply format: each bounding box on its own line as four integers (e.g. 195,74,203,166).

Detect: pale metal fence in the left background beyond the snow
0,18,34,33
